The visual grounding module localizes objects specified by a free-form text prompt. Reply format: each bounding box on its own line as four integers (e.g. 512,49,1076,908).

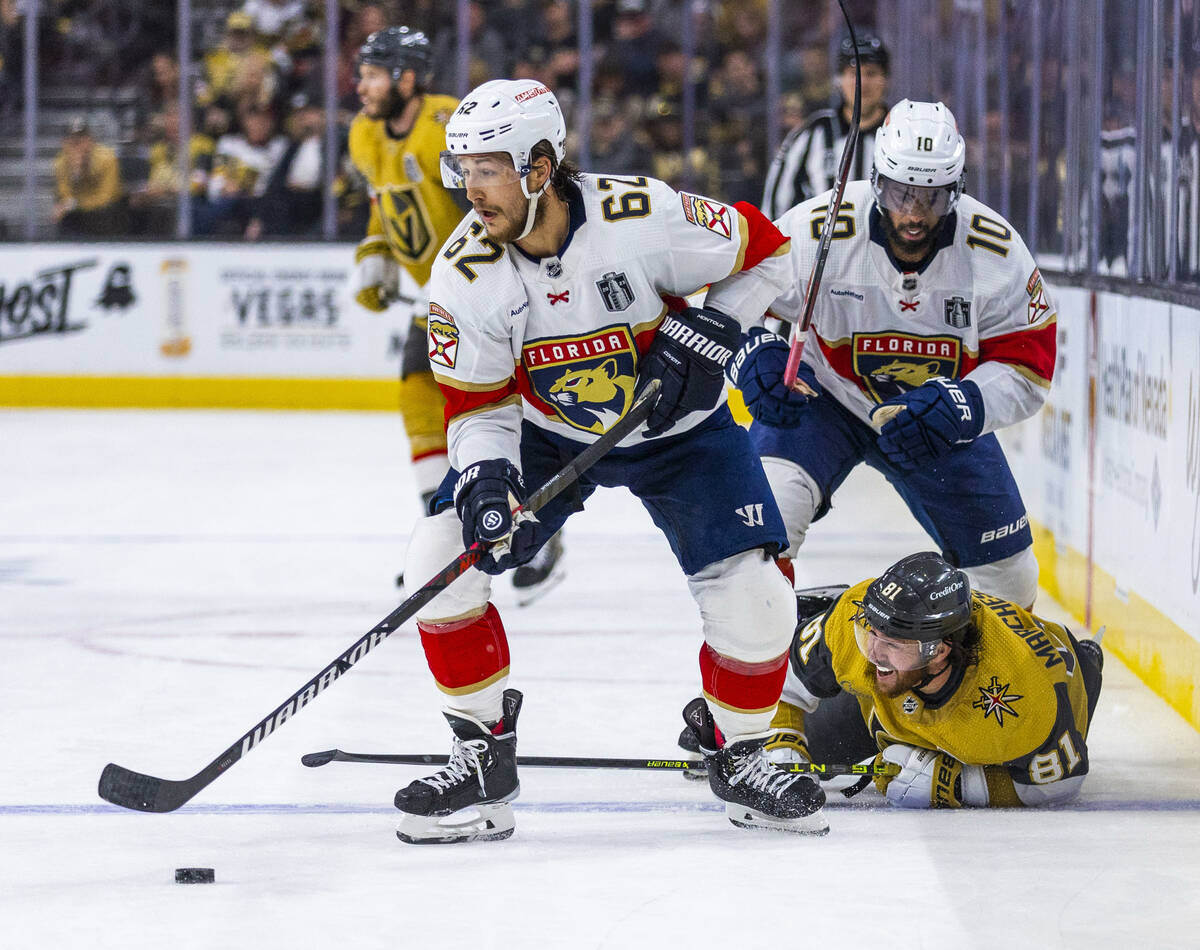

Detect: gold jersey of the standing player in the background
349,95,463,287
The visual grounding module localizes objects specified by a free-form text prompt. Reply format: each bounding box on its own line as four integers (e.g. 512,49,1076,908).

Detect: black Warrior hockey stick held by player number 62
98,380,661,812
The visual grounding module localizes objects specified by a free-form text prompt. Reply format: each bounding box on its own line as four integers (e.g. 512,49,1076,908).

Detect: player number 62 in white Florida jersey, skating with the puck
396,80,828,843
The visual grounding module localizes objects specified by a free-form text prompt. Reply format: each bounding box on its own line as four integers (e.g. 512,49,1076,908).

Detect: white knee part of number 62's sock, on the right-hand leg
688,548,796,663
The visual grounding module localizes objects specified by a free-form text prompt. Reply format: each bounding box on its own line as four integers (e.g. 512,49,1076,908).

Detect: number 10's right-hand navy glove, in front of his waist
875,377,983,470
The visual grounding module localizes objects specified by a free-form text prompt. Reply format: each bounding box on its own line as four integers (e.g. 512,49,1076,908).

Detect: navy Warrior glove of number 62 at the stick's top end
638,307,742,435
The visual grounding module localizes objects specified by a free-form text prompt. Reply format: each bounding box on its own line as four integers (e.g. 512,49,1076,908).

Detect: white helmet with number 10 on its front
871,100,967,215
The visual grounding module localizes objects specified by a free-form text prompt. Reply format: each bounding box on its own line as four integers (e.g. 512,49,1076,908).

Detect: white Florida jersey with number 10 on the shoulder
770,181,1056,432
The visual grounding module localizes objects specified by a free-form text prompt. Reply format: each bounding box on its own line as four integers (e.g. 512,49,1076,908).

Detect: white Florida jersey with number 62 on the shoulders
428,175,788,470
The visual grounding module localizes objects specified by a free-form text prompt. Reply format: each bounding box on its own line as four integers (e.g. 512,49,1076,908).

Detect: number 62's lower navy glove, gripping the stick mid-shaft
454,458,536,575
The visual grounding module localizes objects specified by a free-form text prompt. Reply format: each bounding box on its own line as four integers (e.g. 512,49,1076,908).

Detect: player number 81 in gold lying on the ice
679,553,1104,808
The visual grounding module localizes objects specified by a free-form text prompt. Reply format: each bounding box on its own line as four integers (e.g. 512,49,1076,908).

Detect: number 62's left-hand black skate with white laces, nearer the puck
396,690,522,844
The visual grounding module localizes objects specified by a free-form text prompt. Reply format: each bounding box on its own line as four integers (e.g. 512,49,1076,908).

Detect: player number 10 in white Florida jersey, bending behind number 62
730,100,1056,608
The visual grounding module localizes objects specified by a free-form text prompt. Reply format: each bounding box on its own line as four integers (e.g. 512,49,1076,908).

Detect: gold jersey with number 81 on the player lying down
784,581,1088,806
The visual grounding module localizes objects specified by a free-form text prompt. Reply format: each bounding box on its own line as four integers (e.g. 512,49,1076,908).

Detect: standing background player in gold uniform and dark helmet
349,26,463,510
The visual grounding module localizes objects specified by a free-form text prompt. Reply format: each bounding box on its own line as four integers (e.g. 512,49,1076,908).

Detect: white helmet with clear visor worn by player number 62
442,79,566,188
